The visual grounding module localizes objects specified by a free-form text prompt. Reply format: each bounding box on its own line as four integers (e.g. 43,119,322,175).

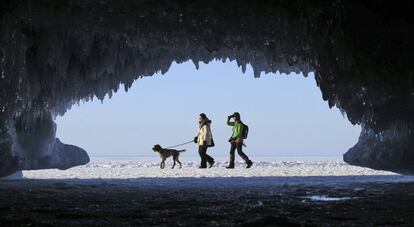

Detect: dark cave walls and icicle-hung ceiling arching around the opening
0,0,414,175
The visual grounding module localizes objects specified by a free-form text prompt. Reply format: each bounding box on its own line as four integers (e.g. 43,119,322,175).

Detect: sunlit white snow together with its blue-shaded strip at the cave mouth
19,160,414,187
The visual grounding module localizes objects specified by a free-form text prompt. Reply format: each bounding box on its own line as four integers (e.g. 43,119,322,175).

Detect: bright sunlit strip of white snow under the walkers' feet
23,161,392,179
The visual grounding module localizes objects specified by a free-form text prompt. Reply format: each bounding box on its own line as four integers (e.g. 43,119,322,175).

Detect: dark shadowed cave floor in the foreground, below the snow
0,178,414,226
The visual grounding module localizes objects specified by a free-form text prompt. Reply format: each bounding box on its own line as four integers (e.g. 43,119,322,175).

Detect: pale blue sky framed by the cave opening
56,61,360,159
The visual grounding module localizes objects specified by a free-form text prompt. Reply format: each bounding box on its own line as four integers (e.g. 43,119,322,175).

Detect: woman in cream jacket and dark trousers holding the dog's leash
194,113,214,169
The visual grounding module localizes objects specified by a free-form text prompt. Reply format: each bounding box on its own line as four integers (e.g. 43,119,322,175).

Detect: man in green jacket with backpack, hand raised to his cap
226,112,253,169
